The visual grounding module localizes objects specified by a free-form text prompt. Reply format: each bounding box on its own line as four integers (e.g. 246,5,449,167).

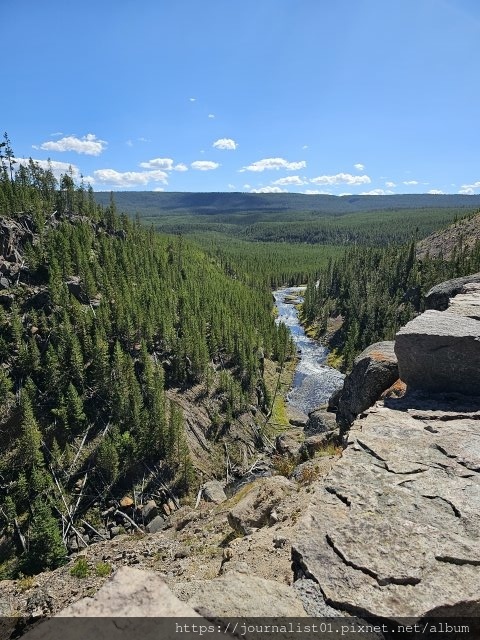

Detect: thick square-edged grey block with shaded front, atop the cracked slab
395,310,480,395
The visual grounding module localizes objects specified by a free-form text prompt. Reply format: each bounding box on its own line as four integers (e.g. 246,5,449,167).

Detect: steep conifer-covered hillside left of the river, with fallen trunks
0,145,292,575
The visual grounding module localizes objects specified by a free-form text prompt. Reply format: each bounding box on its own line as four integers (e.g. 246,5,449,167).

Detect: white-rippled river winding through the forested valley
273,287,345,413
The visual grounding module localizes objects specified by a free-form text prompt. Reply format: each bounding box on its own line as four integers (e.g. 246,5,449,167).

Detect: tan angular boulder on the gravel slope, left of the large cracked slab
228,476,295,535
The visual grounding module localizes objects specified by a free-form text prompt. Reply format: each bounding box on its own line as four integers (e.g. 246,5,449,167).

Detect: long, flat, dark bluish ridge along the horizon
95,191,480,216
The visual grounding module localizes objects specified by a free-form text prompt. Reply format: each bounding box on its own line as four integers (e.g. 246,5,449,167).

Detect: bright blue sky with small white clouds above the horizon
0,0,480,195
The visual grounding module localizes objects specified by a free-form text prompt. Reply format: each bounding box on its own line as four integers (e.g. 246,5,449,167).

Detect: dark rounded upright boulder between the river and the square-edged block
337,341,398,435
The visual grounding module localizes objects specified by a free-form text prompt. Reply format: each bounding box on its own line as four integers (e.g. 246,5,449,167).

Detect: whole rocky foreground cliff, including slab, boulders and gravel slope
4,276,480,638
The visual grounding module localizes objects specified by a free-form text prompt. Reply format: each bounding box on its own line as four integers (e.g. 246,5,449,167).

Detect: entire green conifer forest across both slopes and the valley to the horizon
0,135,480,578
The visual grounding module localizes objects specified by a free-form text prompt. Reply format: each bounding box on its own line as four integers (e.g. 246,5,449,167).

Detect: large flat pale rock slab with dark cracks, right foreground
293,406,480,619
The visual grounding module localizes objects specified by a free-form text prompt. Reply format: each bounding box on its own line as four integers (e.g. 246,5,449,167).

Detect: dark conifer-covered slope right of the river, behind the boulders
302,213,480,370
